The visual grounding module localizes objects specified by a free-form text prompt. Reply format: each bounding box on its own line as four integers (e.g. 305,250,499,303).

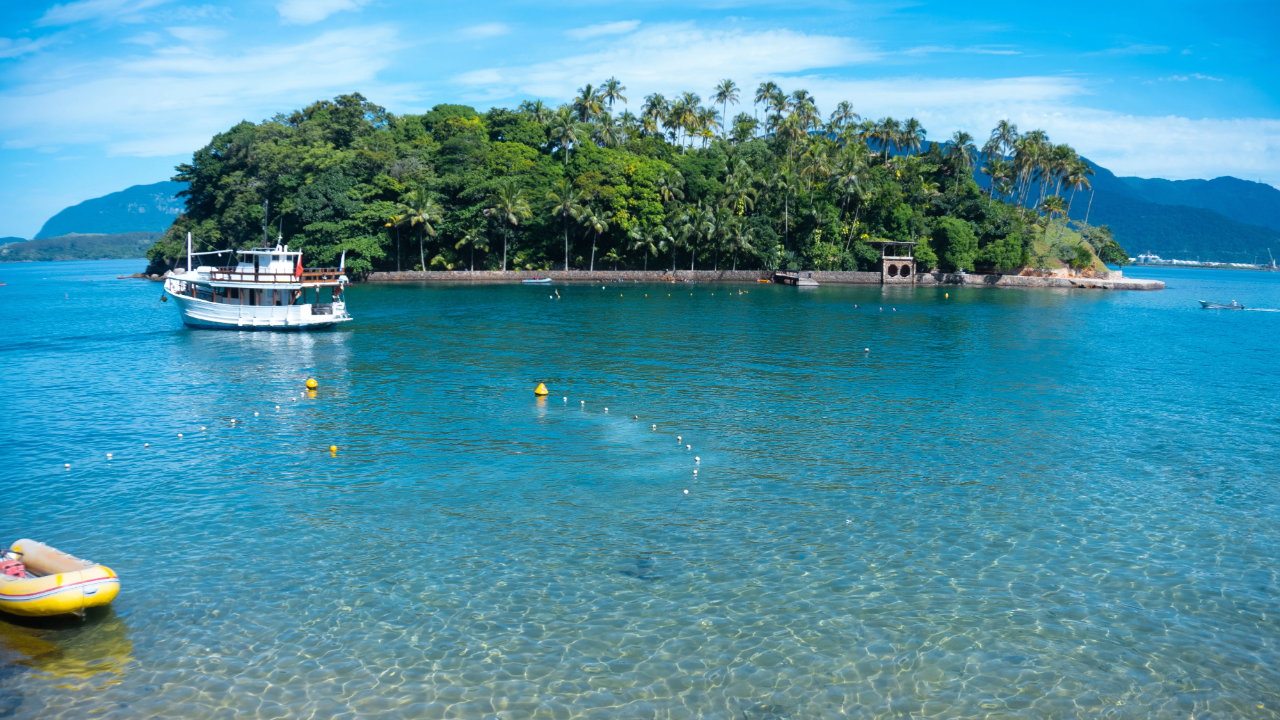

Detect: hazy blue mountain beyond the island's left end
36,181,187,238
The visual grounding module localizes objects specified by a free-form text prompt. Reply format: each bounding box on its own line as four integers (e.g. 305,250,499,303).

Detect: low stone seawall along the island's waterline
365,270,1165,290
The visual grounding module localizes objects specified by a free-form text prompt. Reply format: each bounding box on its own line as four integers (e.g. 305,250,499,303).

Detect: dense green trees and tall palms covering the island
148,78,1126,274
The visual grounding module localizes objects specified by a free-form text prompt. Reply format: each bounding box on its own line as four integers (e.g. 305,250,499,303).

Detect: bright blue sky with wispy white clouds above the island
0,0,1280,238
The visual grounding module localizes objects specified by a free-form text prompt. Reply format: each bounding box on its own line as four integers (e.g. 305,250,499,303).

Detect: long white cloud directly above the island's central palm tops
454,23,878,100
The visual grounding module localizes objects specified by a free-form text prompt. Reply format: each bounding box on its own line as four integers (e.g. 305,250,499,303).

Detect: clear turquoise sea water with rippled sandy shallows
0,261,1280,720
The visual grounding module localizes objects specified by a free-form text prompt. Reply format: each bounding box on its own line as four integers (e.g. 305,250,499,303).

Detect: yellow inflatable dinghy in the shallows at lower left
0,539,120,616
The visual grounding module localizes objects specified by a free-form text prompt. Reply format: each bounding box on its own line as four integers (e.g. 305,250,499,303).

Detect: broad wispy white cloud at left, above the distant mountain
0,24,416,156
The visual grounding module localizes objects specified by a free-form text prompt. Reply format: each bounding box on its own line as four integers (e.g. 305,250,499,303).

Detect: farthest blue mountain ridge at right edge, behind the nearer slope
1120,177,1280,231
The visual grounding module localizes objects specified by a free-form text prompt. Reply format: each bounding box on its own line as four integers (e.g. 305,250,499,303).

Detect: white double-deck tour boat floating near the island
164,233,352,331
